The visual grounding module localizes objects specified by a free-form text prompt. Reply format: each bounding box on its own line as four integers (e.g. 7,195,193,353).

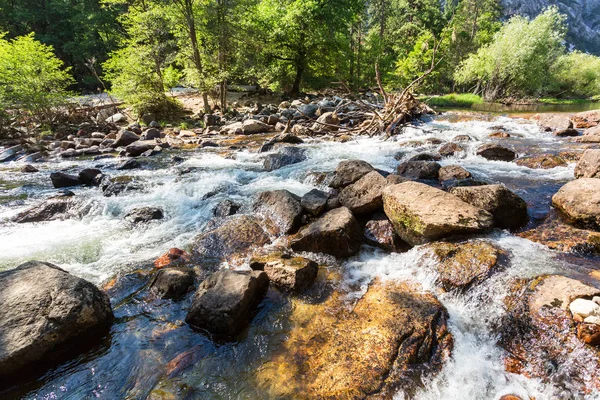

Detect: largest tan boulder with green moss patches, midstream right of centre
383,182,494,245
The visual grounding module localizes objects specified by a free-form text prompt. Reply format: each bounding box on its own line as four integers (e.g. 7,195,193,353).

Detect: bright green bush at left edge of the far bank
0,34,74,123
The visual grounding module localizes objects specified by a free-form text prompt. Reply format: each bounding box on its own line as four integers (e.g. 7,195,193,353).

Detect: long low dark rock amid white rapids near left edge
12,196,84,224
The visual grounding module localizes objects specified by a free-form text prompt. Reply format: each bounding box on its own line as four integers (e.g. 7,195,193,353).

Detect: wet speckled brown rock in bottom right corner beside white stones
500,275,600,398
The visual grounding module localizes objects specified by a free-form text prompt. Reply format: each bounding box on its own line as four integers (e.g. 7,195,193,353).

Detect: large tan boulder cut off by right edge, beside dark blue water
552,178,600,230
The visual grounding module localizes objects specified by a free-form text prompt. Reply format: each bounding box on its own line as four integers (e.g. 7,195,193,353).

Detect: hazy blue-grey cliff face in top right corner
502,0,600,55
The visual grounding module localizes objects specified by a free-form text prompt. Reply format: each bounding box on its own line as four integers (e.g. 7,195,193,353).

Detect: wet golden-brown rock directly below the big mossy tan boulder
427,240,501,290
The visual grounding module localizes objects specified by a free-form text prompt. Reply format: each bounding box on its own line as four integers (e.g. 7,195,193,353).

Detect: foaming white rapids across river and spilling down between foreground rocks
0,117,596,400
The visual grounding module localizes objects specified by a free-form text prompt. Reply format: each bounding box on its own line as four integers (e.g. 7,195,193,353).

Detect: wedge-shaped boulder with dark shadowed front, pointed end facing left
290,207,362,257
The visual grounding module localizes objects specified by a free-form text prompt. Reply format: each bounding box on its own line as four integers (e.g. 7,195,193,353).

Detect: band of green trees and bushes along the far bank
0,0,600,118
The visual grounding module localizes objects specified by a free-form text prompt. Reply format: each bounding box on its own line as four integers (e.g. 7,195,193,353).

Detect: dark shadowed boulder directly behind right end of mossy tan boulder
450,185,528,229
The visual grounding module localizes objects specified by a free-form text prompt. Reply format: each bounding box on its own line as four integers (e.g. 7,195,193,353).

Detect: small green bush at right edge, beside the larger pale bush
551,51,600,97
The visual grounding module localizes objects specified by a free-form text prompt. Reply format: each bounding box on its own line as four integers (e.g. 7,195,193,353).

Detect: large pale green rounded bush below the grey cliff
455,7,566,100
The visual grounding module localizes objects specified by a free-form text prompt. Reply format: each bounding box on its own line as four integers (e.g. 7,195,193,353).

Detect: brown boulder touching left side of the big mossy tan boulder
338,171,387,215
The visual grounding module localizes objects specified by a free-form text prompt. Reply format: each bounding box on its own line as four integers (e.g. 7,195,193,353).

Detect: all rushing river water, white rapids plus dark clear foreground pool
0,113,596,399
